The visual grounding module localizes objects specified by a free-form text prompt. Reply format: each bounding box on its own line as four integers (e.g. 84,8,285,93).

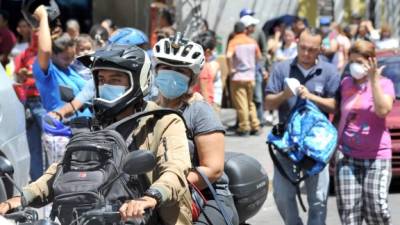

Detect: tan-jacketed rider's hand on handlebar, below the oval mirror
119,196,157,221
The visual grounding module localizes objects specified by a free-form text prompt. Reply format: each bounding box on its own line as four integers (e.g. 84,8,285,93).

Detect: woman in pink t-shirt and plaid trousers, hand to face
335,40,395,225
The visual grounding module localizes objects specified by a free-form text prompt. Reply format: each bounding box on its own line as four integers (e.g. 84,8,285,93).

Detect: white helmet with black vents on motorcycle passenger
153,32,205,85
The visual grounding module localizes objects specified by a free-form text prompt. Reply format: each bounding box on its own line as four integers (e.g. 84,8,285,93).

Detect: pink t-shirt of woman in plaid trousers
339,77,395,159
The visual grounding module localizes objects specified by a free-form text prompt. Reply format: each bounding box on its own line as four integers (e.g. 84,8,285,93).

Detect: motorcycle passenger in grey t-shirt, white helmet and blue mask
153,34,239,225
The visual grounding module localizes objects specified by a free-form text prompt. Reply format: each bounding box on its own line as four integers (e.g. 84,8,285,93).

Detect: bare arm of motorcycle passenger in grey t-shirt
187,132,224,190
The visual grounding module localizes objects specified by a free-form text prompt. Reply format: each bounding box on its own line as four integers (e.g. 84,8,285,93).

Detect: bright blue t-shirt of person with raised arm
32,58,92,117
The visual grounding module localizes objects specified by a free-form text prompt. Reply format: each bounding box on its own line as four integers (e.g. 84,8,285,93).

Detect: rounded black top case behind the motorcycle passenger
224,152,269,223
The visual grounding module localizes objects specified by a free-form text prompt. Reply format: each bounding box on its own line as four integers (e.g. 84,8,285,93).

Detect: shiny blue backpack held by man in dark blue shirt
267,98,338,210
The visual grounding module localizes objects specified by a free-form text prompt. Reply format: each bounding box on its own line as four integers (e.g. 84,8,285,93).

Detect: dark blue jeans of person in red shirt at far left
25,98,46,181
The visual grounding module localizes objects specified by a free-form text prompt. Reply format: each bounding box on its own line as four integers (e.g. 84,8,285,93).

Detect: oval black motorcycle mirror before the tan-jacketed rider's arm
123,150,156,175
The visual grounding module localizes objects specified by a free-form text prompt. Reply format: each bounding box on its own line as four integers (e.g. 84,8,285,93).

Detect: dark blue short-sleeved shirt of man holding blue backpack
265,57,340,123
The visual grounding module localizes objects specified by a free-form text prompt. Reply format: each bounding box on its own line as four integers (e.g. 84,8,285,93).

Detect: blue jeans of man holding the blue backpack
273,154,329,225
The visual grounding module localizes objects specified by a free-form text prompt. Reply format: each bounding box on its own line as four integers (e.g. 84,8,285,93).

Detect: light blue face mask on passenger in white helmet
155,70,190,99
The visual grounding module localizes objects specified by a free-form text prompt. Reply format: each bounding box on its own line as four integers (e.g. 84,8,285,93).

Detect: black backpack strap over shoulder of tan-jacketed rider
105,108,192,140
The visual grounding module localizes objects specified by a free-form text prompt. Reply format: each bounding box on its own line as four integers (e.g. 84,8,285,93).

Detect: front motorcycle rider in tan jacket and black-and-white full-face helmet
0,45,191,225
